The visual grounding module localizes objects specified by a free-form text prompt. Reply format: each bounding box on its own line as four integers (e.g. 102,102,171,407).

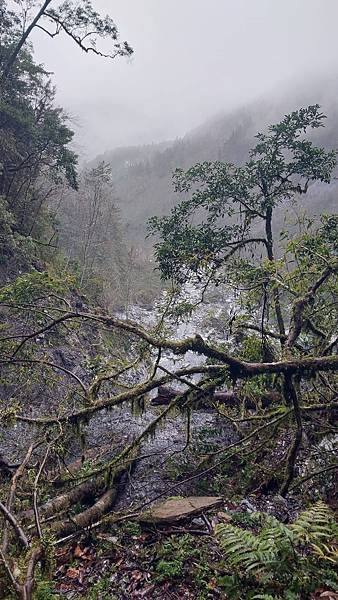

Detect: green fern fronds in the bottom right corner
215,502,337,600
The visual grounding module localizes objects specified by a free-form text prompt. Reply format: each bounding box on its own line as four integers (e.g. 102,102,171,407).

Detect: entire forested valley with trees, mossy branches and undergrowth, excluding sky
0,0,338,600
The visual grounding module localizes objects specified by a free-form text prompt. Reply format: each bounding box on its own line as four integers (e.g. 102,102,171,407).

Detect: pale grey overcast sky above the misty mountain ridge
33,0,338,157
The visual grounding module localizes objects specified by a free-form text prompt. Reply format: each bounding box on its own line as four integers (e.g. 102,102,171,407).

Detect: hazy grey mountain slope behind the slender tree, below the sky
95,80,338,247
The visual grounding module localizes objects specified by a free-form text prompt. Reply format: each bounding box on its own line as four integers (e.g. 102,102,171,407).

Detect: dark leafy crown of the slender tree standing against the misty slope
150,105,336,288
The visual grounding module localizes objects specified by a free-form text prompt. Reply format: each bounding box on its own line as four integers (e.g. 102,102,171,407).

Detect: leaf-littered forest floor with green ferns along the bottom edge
22,502,338,600
